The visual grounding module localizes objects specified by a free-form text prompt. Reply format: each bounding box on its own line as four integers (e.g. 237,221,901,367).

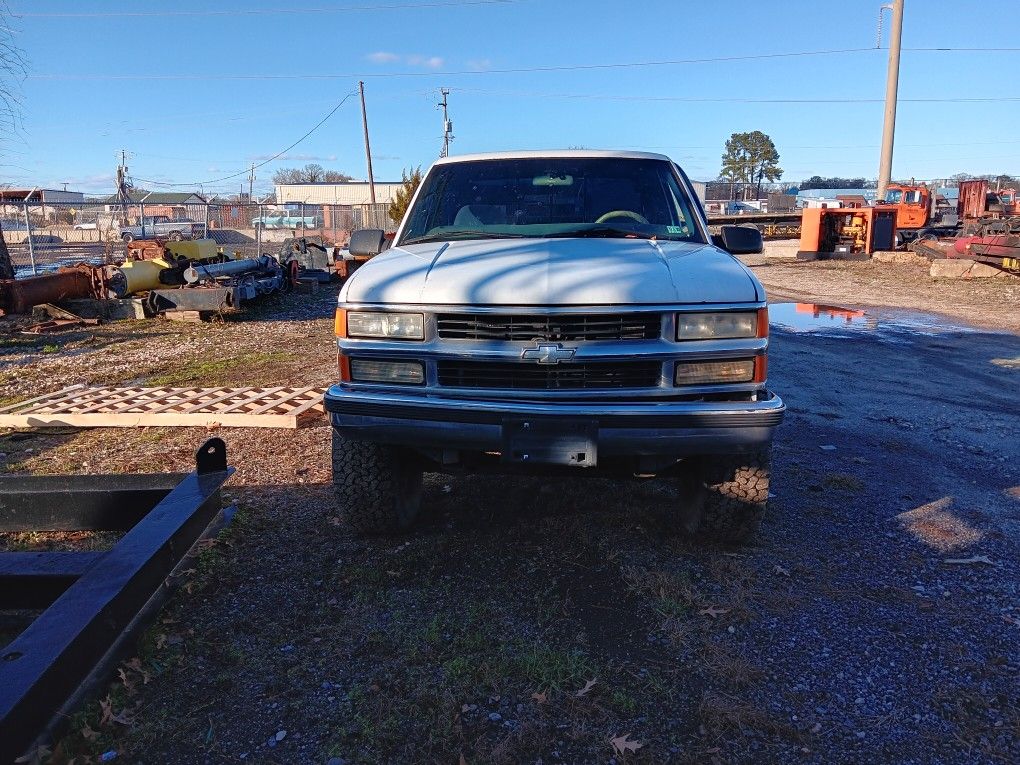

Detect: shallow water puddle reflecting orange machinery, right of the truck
768,303,987,336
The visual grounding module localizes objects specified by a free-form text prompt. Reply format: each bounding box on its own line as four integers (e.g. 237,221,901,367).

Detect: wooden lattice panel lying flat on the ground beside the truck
0,386,324,427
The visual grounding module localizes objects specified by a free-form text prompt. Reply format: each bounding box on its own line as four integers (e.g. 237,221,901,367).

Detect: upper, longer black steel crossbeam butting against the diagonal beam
0,473,184,531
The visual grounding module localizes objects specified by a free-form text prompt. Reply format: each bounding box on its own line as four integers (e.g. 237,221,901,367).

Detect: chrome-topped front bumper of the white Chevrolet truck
325,385,786,461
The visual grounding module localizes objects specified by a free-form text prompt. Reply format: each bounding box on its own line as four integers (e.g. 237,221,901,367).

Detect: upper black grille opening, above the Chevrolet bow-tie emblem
437,313,662,341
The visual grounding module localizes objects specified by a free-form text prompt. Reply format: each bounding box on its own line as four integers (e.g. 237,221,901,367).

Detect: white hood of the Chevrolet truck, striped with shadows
341,239,764,305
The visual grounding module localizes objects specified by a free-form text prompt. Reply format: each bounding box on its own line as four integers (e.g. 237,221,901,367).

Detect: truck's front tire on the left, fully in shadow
333,430,422,534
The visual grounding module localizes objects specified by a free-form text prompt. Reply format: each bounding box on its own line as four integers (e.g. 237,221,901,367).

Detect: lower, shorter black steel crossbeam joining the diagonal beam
0,551,105,608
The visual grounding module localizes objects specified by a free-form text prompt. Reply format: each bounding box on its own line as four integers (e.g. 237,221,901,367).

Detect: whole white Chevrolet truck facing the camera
325,151,785,542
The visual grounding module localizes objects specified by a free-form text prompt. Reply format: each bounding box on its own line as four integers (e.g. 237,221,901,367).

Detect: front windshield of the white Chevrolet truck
400,157,705,245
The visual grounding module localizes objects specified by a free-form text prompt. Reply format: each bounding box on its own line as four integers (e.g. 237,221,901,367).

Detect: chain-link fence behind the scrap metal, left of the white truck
0,201,397,278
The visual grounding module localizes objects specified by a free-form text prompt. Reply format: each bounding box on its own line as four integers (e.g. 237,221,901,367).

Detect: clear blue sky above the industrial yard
0,0,1020,193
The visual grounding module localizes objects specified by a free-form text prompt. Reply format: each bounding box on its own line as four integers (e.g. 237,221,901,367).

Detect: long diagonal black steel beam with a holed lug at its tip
0,439,234,762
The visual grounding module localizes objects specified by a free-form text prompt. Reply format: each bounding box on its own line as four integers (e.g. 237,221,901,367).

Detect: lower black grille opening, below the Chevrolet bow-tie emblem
437,361,662,391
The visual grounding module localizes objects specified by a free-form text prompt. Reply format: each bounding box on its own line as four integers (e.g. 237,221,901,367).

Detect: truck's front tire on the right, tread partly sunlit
698,449,772,544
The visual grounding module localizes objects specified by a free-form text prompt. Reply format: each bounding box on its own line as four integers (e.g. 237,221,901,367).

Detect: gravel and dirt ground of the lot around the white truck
0,258,1020,765
